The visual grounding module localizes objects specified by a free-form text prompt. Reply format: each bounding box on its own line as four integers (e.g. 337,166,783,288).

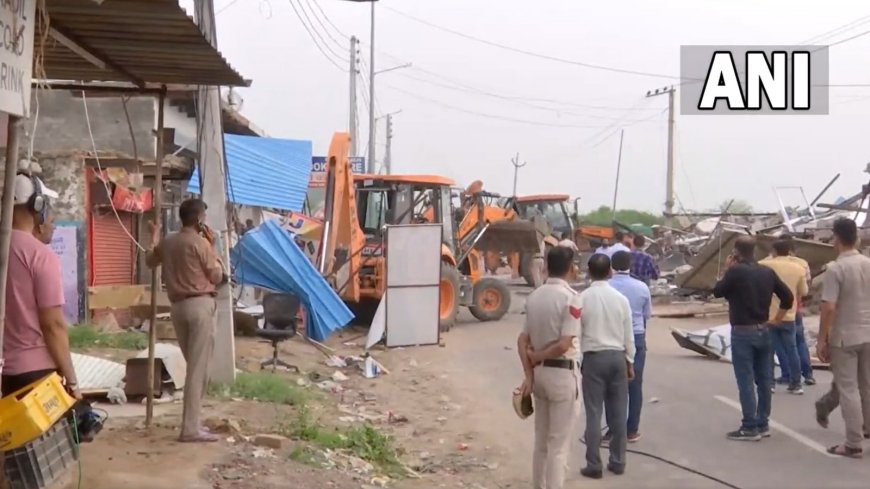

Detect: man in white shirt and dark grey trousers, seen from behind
580,255,635,479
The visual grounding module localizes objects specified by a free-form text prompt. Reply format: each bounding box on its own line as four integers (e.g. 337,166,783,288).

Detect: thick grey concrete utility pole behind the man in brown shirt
196,0,236,384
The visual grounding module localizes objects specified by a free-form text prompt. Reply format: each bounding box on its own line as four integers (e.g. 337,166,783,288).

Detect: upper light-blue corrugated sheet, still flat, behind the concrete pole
187,134,311,212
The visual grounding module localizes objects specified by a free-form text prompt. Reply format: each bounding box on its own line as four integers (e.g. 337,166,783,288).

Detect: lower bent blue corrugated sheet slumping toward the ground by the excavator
230,219,354,341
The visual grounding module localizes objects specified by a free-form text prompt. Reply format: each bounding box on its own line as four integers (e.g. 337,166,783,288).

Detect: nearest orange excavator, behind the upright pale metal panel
321,133,537,331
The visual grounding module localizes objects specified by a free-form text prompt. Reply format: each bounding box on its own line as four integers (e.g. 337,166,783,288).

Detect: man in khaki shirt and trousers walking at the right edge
816,219,870,458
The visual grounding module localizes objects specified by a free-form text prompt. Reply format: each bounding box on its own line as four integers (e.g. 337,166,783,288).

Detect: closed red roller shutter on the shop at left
91,212,134,285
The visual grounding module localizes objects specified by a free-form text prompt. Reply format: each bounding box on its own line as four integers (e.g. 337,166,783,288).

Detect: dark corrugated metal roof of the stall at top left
34,0,250,86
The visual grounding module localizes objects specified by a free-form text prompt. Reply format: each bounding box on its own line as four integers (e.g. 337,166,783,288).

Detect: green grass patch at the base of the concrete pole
209,372,311,406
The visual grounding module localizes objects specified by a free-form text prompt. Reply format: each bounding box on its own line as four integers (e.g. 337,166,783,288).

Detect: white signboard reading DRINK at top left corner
0,0,35,117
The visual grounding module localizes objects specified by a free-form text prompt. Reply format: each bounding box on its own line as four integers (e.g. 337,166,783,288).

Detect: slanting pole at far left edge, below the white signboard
0,114,21,388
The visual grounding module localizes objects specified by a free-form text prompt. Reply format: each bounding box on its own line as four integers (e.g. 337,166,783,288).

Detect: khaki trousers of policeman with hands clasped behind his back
532,366,580,489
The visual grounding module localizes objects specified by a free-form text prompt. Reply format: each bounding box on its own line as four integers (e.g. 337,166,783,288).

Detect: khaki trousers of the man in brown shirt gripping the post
172,296,217,438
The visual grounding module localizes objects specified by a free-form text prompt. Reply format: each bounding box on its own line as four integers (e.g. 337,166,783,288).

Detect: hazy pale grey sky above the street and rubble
182,0,870,211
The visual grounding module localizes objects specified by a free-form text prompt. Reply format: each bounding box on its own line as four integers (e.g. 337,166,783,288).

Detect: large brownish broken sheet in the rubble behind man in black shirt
675,230,837,290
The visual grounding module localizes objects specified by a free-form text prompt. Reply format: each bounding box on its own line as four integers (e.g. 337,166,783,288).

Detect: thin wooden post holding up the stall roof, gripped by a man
145,87,166,427
